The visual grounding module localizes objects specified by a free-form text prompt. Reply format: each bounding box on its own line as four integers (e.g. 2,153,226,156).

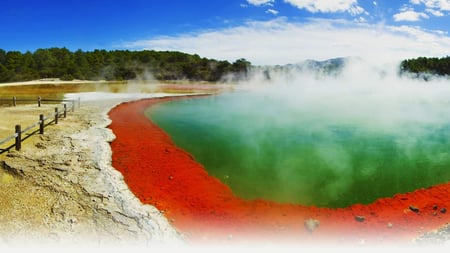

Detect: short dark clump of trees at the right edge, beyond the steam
400,56,450,76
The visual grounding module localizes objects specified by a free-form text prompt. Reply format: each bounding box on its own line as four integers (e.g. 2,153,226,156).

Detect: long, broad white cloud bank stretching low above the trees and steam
122,18,450,65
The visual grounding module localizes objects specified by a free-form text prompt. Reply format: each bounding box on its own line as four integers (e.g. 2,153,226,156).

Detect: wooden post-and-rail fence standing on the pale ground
0,97,80,154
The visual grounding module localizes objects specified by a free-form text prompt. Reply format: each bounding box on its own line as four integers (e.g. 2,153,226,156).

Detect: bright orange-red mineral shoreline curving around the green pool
109,97,450,246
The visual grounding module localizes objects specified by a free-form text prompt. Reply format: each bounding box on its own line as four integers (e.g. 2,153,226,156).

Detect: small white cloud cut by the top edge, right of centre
284,0,364,15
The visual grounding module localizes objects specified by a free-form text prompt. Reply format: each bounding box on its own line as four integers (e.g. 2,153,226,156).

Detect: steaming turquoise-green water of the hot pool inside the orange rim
146,92,450,207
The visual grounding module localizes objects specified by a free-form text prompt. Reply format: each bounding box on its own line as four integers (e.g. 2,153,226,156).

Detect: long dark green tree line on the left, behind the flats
0,48,251,82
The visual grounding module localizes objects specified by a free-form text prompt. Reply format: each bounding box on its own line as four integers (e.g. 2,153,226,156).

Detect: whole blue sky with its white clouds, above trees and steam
0,0,450,64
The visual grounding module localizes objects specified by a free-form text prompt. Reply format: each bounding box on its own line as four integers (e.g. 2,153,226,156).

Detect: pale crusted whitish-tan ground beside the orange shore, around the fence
0,100,183,246
